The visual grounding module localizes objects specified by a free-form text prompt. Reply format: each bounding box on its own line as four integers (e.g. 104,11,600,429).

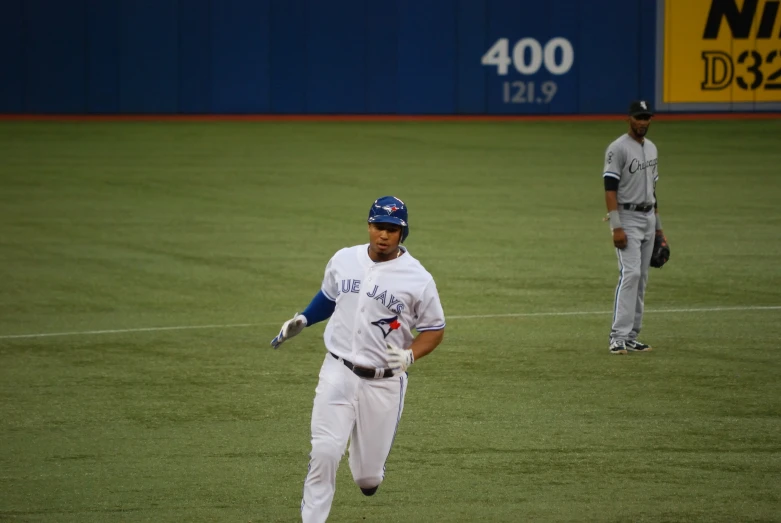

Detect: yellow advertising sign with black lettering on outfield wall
657,0,781,104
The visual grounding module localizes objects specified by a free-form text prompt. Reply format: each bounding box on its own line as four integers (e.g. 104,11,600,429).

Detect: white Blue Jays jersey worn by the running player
321,244,445,367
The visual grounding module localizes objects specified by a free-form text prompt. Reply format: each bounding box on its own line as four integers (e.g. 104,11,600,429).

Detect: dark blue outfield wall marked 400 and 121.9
0,0,656,114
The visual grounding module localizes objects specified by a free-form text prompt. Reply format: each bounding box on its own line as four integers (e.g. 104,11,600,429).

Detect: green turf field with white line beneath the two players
0,120,781,523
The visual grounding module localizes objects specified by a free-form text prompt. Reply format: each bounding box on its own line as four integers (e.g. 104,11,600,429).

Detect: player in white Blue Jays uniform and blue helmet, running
271,196,445,523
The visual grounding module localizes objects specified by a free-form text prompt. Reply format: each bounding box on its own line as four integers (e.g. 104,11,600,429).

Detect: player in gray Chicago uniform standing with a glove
603,100,669,354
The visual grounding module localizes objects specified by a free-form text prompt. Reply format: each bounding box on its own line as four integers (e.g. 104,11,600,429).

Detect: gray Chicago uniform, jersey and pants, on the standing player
603,134,659,342
